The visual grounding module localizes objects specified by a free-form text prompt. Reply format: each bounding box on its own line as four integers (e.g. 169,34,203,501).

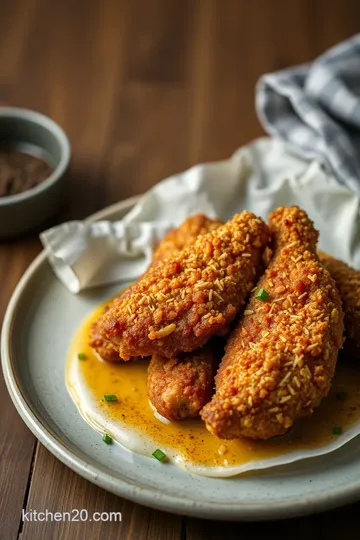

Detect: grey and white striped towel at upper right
256,34,360,196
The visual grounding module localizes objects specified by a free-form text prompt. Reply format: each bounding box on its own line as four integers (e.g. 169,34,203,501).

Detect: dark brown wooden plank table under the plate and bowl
0,0,360,540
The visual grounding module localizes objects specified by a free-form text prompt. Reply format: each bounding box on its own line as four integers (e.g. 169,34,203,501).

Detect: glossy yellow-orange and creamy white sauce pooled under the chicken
66,306,360,476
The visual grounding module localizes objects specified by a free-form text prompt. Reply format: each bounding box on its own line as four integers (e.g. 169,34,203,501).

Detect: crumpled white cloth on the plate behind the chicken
40,138,360,293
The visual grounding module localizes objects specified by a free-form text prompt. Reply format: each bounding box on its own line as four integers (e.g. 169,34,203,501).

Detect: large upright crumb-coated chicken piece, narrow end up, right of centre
201,207,343,439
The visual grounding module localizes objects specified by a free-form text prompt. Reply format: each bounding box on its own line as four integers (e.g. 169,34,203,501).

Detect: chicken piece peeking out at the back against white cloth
152,214,223,265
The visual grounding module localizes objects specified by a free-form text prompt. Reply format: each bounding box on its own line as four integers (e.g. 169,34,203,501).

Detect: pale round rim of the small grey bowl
0,107,71,207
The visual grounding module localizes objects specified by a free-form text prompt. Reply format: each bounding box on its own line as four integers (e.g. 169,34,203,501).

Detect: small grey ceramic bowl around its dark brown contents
0,107,71,239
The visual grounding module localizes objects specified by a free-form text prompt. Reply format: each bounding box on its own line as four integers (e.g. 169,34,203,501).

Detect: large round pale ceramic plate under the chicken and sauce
1,199,360,520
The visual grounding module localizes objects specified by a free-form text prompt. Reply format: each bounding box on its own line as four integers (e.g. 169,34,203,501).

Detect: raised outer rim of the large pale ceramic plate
1,196,360,521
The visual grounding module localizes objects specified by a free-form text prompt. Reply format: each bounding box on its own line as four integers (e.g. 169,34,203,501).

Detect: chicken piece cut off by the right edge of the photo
318,251,360,359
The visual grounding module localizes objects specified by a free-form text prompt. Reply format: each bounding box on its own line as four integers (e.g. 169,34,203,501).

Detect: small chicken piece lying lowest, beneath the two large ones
147,339,221,420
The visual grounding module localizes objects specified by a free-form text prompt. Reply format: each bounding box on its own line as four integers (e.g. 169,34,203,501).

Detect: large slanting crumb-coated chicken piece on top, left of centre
101,211,268,359
